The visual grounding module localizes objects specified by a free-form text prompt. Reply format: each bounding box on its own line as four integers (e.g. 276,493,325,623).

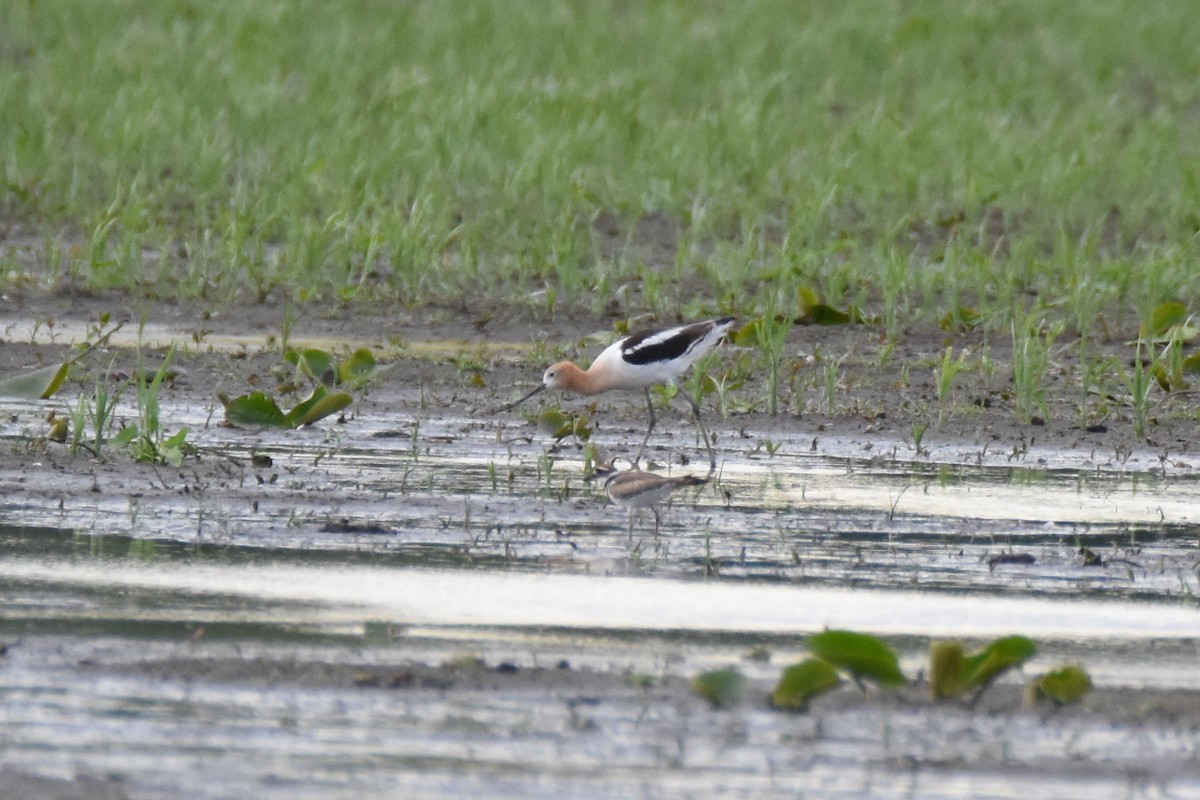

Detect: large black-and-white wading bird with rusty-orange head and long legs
503,317,733,474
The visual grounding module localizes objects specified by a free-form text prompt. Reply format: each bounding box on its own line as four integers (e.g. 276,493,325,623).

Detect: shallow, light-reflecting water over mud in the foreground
0,357,1200,798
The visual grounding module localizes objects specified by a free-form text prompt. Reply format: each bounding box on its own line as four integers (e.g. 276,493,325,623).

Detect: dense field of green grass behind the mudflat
0,0,1200,335
